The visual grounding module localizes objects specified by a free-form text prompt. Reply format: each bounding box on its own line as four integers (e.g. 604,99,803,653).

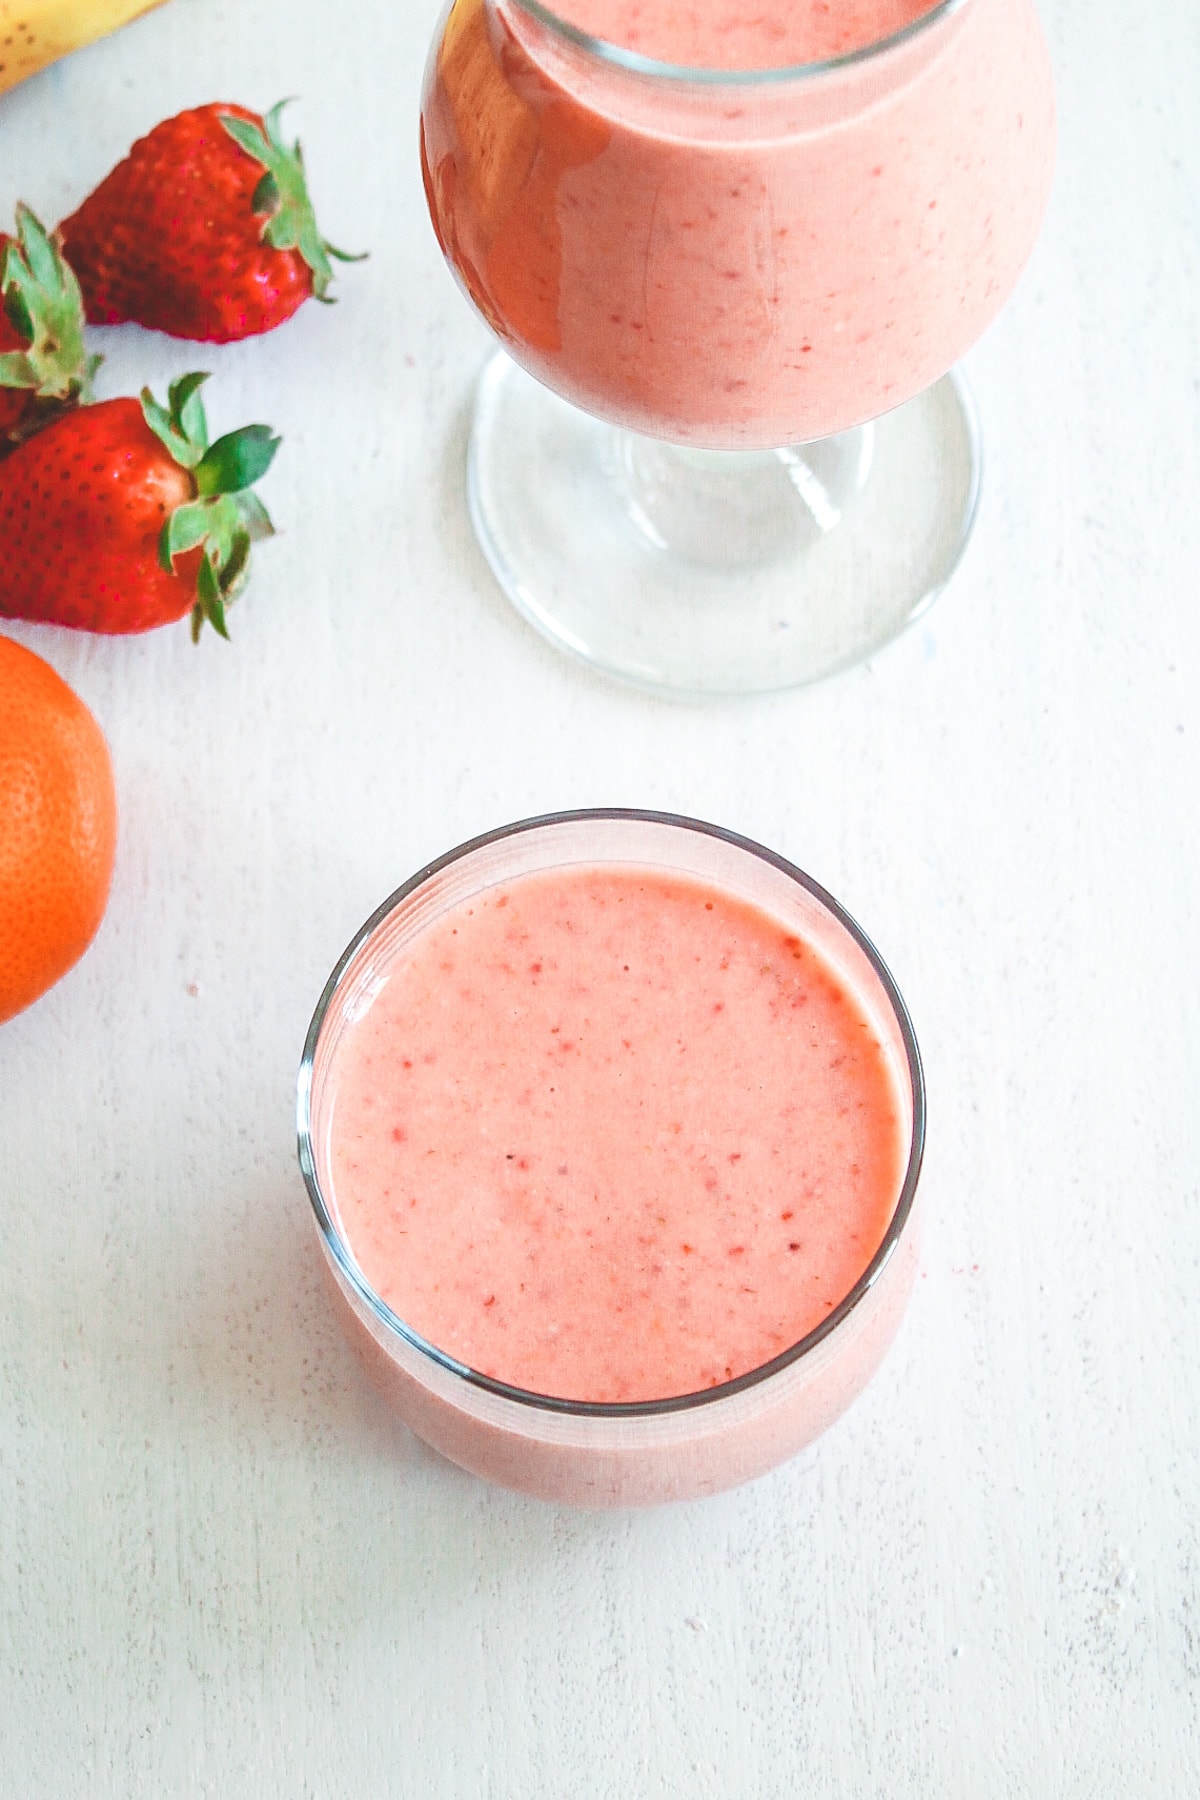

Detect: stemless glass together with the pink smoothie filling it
297,808,925,1507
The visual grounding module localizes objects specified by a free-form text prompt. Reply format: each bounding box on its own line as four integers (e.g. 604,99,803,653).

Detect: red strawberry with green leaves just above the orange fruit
0,374,279,637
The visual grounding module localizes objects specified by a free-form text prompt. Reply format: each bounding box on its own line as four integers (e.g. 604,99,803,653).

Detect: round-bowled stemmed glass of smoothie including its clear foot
421,0,1054,693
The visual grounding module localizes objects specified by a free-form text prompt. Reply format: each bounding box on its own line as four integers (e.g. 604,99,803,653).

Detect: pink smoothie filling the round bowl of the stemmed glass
421,0,1054,448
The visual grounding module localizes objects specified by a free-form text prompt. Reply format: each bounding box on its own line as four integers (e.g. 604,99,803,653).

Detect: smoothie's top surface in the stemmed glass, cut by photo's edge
528,0,937,70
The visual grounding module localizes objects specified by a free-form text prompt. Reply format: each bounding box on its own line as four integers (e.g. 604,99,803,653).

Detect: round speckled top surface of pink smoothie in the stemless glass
327,866,909,1400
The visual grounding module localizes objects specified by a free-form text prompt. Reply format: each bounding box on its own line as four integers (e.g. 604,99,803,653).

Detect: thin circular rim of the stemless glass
297,806,925,1418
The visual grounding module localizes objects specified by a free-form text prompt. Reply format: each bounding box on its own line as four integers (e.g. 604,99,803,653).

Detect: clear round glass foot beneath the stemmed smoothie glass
468,353,981,695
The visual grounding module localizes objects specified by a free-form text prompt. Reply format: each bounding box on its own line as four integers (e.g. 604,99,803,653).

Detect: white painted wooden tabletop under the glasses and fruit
0,0,1200,1800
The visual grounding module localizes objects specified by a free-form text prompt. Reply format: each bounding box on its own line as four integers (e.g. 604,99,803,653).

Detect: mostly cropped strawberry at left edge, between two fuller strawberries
0,205,101,455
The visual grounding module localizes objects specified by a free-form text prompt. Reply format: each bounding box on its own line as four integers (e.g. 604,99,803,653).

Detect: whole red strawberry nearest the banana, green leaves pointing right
59,101,356,344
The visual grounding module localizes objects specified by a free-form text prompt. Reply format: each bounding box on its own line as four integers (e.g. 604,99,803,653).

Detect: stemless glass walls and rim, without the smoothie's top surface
297,806,925,1507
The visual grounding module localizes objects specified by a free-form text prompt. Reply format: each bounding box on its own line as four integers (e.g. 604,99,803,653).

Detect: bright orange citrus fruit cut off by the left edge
0,637,117,1022
